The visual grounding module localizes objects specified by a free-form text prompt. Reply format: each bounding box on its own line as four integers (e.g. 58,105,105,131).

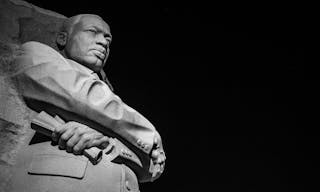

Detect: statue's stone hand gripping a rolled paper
52,121,109,155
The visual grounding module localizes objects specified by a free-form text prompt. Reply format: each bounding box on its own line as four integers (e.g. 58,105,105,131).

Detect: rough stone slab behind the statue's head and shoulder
0,0,66,166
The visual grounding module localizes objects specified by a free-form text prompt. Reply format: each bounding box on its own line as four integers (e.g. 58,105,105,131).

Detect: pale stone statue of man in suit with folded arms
0,7,165,192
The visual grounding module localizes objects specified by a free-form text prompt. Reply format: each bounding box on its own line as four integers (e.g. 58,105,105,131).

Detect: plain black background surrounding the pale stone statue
25,0,312,191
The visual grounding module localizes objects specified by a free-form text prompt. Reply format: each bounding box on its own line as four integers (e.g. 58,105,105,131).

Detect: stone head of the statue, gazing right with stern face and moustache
56,14,112,72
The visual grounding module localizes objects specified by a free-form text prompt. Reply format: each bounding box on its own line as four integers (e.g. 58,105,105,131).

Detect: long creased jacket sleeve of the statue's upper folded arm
15,42,159,181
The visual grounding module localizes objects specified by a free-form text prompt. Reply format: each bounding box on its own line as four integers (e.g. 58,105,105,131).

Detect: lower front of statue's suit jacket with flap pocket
0,136,139,192
